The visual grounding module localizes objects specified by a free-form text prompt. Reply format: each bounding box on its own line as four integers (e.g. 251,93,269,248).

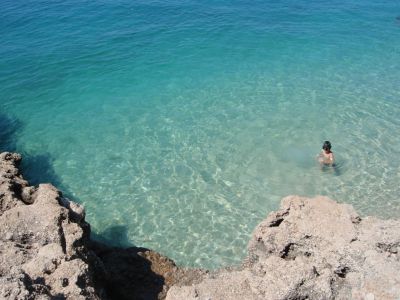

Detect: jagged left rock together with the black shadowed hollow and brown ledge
0,153,202,300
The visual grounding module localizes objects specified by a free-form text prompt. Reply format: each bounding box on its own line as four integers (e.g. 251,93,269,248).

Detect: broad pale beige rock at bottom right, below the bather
167,196,400,300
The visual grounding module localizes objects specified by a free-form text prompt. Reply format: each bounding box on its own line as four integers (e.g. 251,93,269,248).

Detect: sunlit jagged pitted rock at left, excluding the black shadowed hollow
0,153,103,299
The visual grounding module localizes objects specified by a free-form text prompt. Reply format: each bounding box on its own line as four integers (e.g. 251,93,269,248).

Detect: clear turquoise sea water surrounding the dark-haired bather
0,0,400,268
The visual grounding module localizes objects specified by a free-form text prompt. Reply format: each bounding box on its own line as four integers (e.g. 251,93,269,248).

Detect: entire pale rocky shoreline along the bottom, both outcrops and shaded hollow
0,152,400,300
